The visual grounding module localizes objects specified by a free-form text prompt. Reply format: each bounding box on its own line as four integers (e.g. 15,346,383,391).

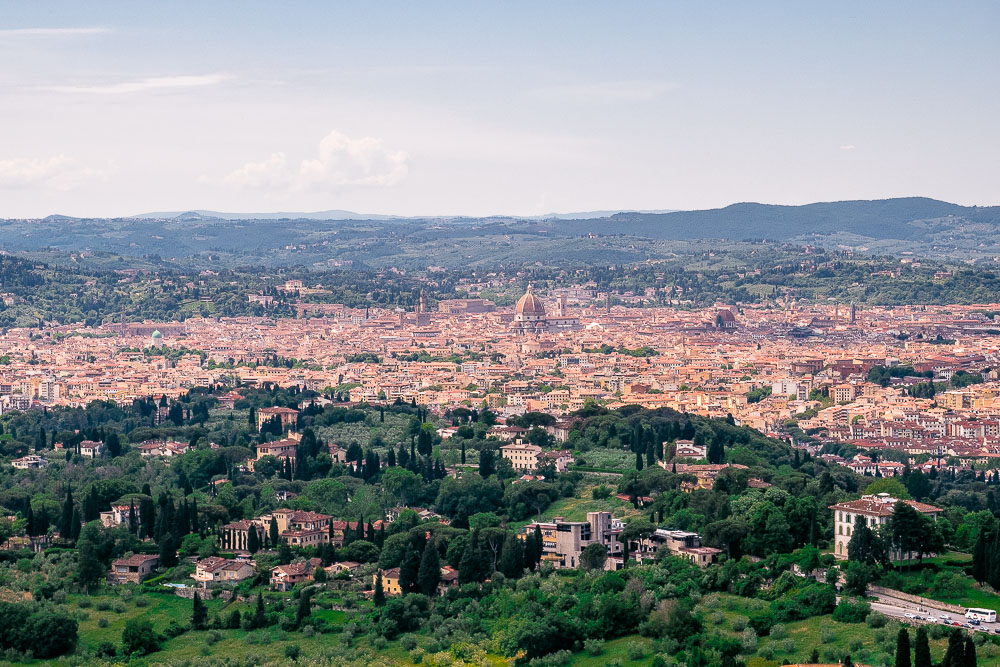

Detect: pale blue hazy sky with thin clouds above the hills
0,0,1000,217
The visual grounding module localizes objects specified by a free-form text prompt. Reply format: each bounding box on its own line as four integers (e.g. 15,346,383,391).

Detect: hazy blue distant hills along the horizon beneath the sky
11,197,1000,268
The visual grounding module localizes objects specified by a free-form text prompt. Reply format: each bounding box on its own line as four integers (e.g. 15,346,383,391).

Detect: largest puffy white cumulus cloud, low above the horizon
225,130,410,192
